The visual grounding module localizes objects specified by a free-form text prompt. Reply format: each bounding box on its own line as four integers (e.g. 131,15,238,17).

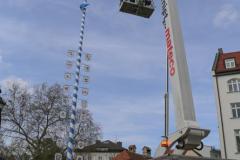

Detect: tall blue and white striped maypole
67,0,89,160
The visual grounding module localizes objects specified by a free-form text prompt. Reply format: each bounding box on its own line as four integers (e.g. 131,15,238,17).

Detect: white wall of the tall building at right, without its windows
214,74,240,160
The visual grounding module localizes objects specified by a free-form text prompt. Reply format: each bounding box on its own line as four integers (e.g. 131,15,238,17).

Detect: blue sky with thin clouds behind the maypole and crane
0,0,240,153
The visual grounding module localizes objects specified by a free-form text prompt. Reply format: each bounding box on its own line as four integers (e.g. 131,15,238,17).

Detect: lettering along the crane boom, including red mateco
161,0,176,76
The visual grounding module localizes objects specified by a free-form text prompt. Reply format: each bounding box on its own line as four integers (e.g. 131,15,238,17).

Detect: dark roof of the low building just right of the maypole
75,140,126,153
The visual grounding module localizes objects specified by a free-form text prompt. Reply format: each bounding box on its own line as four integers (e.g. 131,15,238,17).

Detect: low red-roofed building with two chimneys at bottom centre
113,145,152,160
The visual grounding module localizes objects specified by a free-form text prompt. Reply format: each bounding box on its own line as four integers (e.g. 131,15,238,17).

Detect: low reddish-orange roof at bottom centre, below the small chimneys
113,150,151,160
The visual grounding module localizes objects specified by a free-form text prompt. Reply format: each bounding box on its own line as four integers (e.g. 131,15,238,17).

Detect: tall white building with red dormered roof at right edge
212,49,240,159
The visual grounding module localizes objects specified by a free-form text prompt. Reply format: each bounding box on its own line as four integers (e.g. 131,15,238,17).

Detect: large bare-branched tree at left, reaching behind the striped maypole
2,82,101,160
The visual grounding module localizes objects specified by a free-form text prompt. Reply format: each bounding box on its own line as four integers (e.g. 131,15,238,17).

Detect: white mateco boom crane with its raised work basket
120,0,210,154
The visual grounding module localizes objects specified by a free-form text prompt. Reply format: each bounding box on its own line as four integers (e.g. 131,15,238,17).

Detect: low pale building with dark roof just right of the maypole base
75,140,126,160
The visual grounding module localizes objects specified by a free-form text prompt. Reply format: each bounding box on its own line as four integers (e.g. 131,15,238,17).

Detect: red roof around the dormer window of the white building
212,49,240,75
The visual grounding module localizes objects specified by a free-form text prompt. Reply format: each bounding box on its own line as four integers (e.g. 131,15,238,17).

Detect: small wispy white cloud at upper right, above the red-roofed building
213,4,240,28
